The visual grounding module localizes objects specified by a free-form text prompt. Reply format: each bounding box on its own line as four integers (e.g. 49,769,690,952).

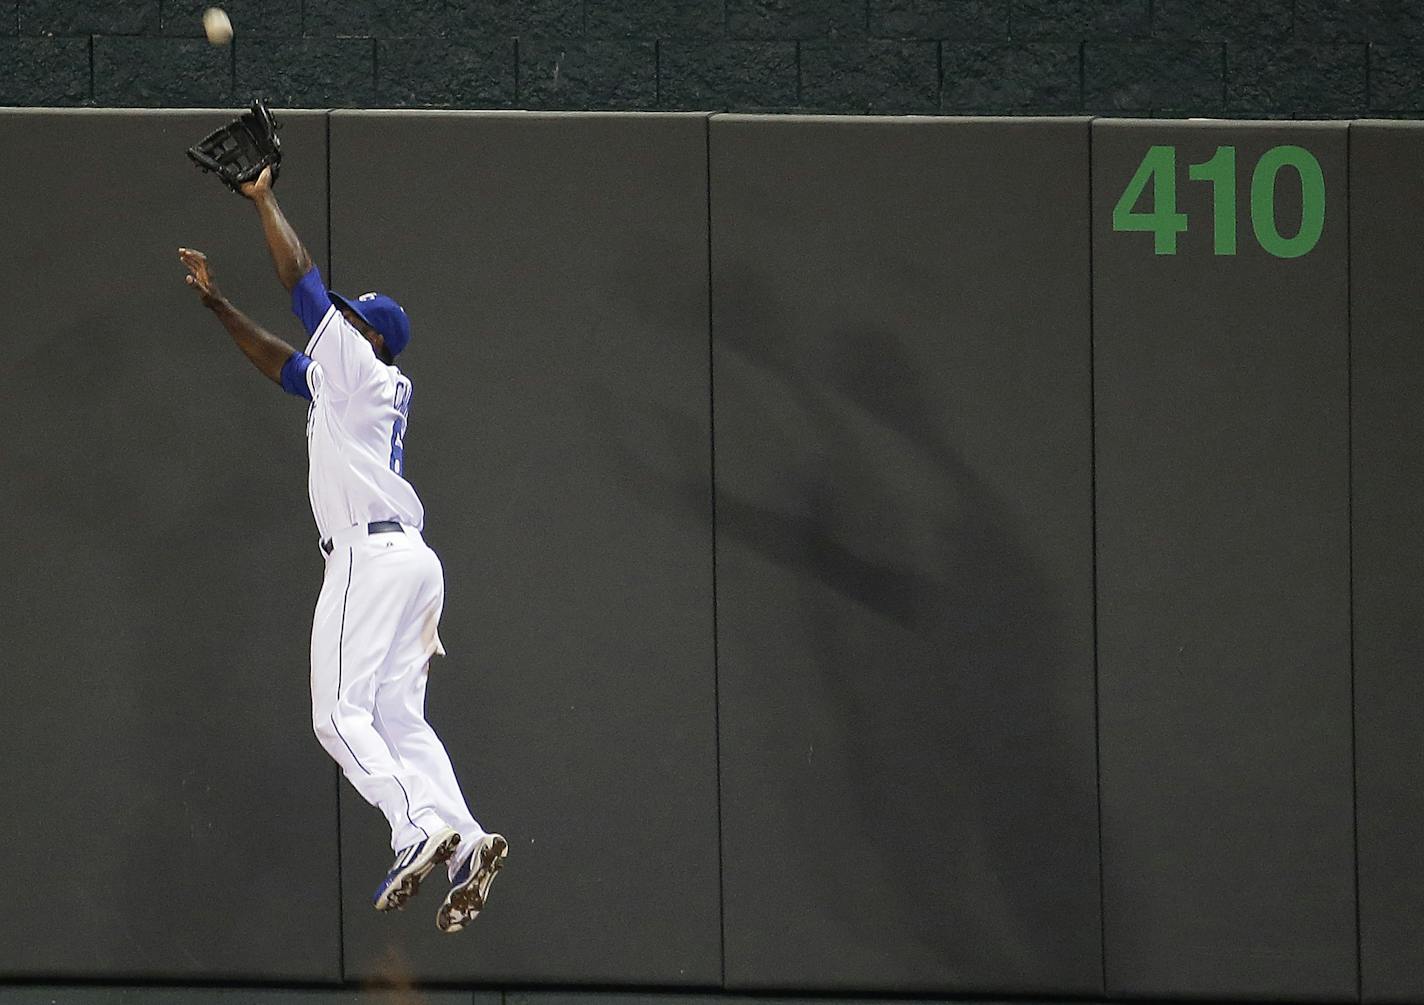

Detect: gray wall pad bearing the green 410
1092,120,1356,998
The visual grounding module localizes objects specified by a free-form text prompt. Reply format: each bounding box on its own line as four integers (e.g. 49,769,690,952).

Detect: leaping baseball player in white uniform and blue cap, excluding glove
178,168,508,932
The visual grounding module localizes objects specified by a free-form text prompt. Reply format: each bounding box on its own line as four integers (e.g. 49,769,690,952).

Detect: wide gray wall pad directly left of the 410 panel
712,117,1101,995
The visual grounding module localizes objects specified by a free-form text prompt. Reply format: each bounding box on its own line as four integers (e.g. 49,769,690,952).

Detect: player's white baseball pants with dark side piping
312,525,484,874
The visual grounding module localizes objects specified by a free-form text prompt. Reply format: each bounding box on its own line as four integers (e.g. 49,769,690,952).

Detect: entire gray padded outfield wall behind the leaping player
0,110,1424,1001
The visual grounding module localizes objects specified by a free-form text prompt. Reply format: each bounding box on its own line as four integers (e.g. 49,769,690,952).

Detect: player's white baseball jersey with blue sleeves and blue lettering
282,268,424,541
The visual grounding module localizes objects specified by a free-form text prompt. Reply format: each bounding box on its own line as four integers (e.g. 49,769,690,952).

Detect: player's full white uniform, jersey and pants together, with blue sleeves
282,266,484,875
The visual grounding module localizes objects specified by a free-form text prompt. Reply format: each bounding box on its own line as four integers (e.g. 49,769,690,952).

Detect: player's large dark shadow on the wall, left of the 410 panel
591,266,1096,981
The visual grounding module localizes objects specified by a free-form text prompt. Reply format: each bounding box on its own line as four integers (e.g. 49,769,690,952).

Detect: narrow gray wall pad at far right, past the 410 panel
1350,122,1424,1001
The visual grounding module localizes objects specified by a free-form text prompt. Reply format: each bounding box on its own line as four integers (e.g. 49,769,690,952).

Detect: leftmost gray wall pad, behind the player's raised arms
0,111,340,979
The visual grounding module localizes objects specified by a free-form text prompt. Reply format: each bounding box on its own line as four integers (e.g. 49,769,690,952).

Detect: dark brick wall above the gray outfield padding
0,0,1424,118
